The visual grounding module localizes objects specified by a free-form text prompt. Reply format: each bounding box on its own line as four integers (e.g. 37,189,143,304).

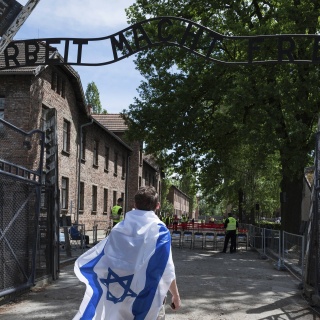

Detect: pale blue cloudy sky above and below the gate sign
14,0,142,113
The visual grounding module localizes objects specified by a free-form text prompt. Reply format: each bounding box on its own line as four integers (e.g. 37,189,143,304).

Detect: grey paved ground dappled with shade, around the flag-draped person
0,248,320,320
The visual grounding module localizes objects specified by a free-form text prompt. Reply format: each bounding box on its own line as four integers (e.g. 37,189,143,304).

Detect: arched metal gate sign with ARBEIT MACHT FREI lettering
2,17,320,69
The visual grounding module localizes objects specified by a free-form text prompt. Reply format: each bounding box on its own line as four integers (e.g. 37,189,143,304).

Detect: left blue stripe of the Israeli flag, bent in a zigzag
80,249,104,320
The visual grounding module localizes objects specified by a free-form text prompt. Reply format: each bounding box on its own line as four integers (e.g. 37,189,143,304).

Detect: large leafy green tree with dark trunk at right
125,0,320,233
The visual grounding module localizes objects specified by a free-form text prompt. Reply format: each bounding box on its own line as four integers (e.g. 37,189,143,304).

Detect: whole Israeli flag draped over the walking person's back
73,210,175,320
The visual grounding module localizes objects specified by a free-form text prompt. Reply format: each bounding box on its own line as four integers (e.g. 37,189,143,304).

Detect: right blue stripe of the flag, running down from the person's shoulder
132,224,171,320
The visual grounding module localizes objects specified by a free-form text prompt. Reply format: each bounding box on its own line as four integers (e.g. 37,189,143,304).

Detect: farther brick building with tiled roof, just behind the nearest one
93,114,161,210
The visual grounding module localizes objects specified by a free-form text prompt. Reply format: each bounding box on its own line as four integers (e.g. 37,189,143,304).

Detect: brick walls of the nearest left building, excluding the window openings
0,67,129,230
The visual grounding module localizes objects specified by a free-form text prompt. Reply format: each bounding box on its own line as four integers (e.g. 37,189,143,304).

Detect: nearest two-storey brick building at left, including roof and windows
0,44,132,230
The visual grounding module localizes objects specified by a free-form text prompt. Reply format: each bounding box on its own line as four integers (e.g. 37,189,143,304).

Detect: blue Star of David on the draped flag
100,268,137,304
